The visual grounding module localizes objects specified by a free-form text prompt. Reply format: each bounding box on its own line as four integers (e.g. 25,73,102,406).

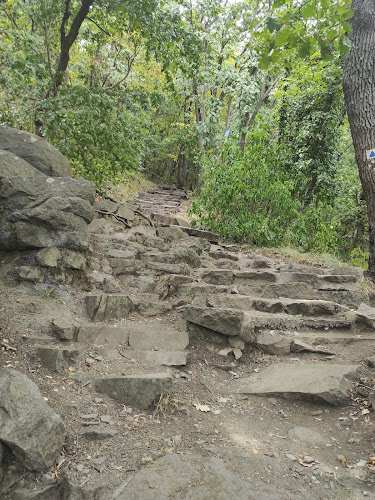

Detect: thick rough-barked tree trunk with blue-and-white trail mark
343,0,375,276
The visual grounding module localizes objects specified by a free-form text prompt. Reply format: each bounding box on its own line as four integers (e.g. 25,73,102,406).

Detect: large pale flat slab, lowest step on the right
234,363,359,406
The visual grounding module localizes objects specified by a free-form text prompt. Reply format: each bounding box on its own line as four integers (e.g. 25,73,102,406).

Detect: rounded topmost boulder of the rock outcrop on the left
0,125,72,177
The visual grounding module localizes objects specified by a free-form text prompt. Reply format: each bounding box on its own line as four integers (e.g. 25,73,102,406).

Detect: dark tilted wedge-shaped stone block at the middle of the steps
183,306,243,336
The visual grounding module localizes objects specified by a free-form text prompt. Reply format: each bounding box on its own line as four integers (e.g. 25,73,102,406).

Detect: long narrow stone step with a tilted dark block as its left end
183,306,353,342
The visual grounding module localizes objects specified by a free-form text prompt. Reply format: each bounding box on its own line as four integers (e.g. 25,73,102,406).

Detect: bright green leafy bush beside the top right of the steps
193,135,297,246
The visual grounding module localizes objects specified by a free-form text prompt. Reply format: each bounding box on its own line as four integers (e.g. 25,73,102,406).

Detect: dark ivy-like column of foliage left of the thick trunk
279,62,344,206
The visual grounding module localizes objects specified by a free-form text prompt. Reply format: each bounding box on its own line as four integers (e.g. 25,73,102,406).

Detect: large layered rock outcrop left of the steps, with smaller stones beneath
0,126,95,284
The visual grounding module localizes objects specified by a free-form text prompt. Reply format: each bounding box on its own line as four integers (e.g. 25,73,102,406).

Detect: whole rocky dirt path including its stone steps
0,188,375,500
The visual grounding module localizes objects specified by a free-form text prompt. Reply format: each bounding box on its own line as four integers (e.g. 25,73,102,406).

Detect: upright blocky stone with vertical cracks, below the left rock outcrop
86,294,133,321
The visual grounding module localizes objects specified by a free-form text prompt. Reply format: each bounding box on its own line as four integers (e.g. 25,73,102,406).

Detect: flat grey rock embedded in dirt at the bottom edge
110,453,284,500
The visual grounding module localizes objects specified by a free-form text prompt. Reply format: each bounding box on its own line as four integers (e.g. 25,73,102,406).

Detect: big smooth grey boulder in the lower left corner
0,369,65,471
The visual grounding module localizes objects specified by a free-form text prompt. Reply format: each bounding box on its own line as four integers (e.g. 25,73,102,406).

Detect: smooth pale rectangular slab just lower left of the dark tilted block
128,322,189,351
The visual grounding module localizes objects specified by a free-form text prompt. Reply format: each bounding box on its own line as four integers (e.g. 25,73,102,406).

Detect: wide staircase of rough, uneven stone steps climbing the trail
4,185,375,498
